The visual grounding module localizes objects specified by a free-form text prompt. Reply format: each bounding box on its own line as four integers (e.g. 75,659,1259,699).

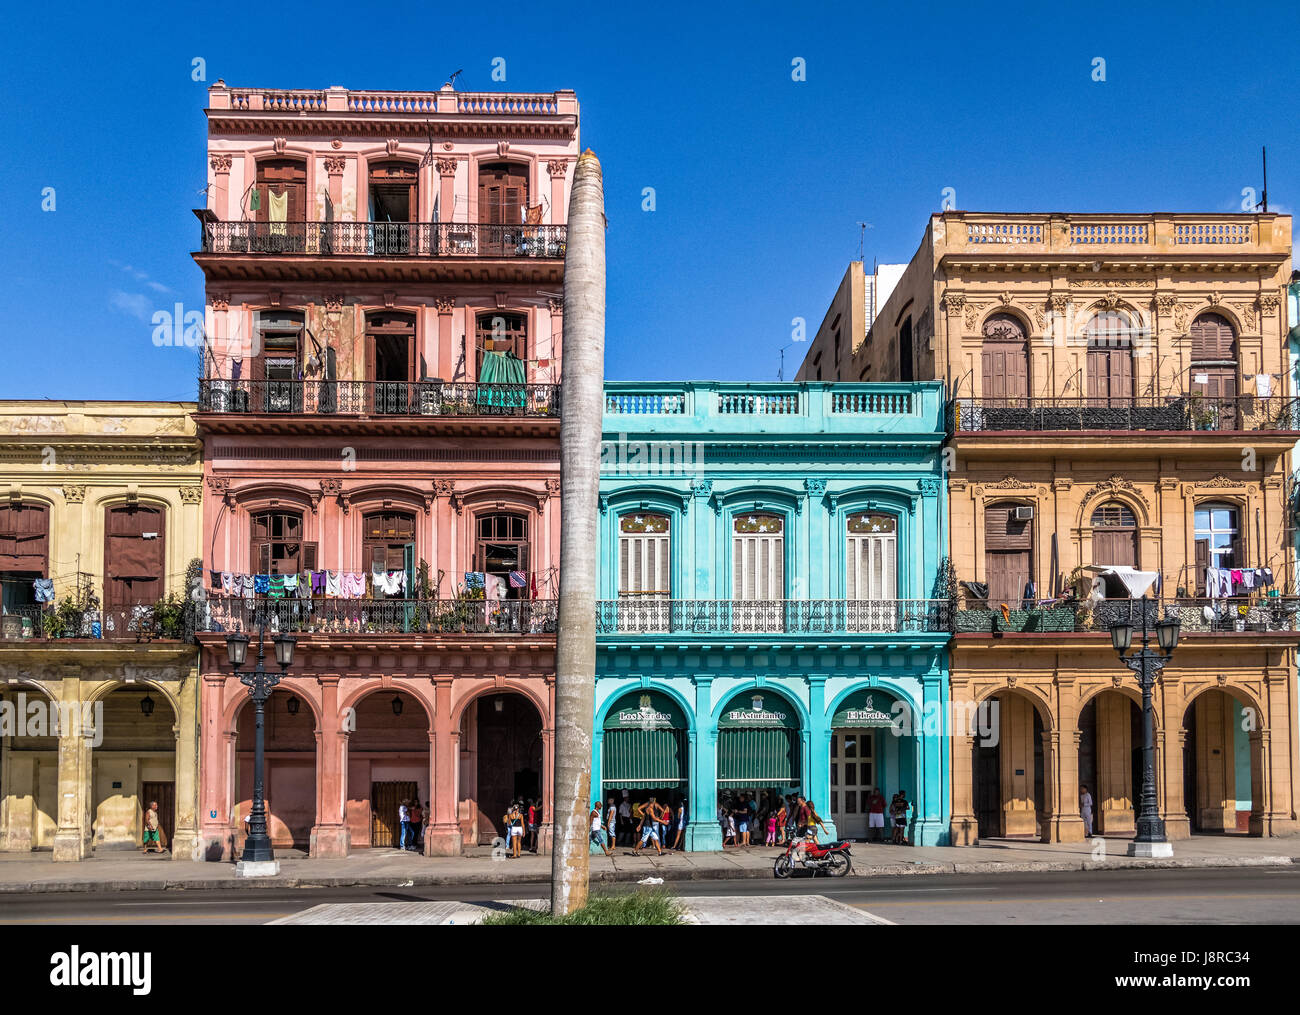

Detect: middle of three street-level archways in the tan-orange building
1079,690,1143,836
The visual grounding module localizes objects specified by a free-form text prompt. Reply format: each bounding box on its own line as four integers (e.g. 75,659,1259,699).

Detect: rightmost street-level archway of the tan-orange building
1183,687,1264,834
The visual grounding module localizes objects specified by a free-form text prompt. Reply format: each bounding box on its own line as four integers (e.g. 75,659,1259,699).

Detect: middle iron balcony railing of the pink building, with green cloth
199,378,560,417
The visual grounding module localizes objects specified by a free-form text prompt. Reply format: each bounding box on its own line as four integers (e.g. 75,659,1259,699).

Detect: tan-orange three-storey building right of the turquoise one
800,212,1300,845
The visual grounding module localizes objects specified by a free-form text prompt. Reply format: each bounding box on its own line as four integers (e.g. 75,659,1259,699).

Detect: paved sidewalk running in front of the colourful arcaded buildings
0,836,1300,895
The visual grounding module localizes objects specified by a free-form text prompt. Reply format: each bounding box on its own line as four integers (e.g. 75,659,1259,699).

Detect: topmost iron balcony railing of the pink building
200,221,568,260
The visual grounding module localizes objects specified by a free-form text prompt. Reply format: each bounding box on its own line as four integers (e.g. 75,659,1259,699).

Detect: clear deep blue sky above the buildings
0,0,1300,399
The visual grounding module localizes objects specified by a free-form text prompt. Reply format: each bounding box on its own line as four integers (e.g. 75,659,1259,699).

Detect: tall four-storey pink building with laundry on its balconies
194,82,579,859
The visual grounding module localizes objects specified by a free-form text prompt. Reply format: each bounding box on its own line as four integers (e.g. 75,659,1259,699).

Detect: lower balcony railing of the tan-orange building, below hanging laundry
954,595,1300,634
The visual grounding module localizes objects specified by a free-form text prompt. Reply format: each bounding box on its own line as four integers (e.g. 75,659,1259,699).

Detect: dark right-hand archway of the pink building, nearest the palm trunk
460,690,542,845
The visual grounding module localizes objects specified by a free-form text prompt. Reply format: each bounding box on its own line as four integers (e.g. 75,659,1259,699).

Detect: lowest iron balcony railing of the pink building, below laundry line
196,597,559,636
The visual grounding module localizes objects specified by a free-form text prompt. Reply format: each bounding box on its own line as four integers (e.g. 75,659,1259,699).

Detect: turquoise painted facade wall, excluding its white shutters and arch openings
593,382,950,849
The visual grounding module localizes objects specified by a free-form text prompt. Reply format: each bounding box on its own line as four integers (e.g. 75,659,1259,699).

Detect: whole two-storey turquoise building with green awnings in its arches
592,382,950,850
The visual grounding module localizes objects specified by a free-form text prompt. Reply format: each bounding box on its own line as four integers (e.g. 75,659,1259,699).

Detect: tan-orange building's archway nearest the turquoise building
971,691,1050,842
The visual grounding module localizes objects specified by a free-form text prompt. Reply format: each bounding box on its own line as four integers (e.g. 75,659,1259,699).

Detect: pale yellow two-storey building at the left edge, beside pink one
0,402,203,860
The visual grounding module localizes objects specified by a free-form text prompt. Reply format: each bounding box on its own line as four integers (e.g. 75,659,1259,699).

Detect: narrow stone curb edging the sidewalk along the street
0,856,1300,895
